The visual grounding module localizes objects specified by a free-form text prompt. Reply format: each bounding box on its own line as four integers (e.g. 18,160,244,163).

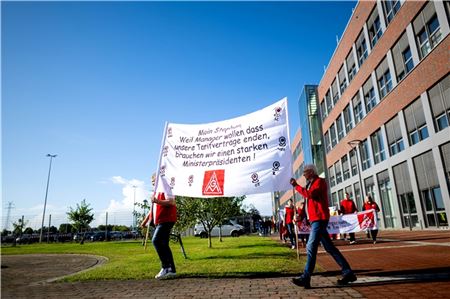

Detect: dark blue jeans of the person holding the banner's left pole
152,222,176,272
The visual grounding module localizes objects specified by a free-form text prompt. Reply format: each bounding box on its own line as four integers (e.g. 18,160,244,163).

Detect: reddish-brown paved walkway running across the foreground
1,230,450,298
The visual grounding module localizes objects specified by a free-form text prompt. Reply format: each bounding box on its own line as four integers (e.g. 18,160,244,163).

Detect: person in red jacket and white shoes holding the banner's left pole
141,193,177,279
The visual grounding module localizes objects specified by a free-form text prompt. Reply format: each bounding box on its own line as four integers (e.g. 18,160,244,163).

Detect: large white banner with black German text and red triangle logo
156,98,292,197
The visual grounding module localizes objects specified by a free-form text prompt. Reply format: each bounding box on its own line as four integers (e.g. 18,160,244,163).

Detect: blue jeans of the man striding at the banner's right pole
303,220,353,279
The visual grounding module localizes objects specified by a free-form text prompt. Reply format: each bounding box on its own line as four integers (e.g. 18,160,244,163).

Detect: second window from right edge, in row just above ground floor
404,98,428,145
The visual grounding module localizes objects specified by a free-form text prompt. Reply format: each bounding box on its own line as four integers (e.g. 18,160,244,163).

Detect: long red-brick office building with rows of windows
318,1,450,229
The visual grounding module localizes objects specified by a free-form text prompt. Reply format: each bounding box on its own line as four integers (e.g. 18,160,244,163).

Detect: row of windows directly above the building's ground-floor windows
325,75,450,187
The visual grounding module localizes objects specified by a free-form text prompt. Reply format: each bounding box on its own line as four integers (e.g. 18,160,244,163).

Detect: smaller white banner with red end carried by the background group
299,210,378,234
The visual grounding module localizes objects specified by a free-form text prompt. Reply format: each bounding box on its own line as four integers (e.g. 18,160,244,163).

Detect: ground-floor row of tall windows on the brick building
331,142,450,228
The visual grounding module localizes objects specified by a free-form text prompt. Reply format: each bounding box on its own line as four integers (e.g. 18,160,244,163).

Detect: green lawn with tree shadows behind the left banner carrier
2,236,305,281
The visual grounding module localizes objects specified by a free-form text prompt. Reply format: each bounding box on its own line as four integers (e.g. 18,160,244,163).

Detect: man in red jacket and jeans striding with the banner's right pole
290,164,357,289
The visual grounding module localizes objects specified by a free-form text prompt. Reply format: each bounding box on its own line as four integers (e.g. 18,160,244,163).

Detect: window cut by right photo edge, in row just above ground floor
428,75,450,132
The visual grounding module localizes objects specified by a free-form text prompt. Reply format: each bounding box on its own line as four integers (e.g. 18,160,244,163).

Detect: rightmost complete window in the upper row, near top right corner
413,1,442,58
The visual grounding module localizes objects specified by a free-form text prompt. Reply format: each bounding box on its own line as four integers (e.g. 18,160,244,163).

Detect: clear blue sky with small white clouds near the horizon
1,2,356,228
